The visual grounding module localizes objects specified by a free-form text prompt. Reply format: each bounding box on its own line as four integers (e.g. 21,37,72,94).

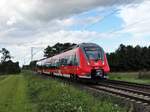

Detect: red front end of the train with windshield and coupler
78,43,110,79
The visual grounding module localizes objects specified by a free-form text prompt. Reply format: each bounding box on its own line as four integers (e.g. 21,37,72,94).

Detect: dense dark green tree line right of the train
107,44,150,71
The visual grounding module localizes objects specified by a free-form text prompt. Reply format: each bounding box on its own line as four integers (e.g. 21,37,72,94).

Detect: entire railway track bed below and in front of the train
38,73,150,106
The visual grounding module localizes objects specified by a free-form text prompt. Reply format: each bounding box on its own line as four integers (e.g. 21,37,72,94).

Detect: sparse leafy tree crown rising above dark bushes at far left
0,48,11,63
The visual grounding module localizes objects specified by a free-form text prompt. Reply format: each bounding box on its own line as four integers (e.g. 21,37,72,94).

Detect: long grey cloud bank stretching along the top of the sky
0,0,140,22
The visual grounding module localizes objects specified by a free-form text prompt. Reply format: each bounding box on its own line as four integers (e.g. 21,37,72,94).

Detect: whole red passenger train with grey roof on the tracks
36,43,110,79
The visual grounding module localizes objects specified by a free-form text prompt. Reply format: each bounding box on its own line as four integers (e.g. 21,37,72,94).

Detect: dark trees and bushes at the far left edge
0,48,20,74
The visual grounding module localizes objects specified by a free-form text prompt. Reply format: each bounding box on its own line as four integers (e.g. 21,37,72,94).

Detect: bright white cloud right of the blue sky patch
119,0,150,37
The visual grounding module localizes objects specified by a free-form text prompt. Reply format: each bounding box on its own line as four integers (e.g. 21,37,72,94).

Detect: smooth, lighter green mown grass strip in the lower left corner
0,75,32,112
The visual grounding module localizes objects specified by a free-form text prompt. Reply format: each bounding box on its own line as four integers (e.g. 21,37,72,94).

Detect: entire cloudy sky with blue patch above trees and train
0,0,150,66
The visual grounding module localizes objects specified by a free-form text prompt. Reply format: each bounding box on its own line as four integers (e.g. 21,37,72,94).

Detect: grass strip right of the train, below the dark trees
109,72,150,84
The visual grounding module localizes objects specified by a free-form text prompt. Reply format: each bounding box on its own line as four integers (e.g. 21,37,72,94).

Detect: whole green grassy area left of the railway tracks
0,72,126,112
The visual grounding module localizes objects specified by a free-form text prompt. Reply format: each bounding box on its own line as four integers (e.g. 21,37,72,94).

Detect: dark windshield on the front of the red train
84,47,103,60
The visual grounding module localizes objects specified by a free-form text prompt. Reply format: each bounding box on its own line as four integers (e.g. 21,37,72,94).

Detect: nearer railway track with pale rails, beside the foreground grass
88,83,150,105
